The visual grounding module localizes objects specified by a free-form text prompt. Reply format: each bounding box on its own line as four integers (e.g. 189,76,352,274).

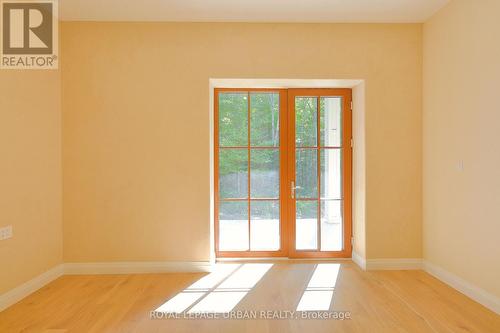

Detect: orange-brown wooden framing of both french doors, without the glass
214,88,352,258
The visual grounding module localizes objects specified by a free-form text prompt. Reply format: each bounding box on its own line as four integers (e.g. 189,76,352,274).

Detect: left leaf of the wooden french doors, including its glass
214,89,288,257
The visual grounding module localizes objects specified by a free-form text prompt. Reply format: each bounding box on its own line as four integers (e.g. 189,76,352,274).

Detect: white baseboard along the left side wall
0,264,64,311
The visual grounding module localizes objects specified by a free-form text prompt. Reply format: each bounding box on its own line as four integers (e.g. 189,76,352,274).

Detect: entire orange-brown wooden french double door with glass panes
214,88,352,258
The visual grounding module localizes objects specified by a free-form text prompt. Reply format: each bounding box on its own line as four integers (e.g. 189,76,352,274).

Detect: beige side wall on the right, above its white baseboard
423,0,500,296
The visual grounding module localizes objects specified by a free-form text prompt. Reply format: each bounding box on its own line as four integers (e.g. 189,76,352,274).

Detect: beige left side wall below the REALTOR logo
0,70,62,294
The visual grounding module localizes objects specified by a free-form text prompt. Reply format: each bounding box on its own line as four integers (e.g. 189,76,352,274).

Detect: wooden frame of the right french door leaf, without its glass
287,88,352,258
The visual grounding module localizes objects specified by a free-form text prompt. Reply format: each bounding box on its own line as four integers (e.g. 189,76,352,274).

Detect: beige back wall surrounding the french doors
61,22,422,262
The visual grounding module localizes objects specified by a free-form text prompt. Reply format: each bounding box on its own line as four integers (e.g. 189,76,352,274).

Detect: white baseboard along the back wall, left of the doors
64,261,212,275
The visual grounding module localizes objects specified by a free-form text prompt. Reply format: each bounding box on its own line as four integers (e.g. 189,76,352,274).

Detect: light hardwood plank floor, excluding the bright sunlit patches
0,261,500,333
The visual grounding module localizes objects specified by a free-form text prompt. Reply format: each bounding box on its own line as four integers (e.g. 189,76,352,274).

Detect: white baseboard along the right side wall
423,260,500,315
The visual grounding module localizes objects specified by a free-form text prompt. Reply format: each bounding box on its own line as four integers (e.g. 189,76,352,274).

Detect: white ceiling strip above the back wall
59,0,449,22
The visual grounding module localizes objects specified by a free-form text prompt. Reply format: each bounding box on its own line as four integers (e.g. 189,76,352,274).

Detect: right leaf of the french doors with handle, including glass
287,89,352,258
